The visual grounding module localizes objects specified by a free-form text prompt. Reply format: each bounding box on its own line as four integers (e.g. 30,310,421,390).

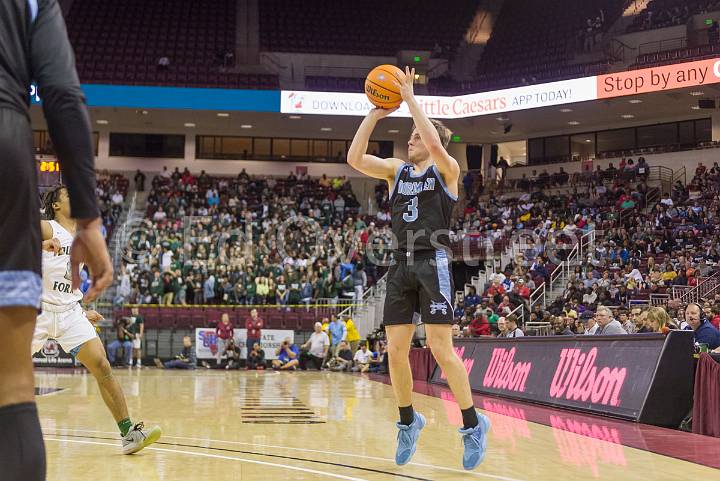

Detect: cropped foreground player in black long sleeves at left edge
0,0,112,481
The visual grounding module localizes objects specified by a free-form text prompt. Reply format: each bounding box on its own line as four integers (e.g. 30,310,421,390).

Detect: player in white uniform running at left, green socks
37,185,162,454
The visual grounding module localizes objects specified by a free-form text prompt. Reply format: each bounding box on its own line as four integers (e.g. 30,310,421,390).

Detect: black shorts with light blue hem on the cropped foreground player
0,108,42,308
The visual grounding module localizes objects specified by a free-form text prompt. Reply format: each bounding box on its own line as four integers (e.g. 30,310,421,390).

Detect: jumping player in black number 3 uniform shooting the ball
348,68,490,469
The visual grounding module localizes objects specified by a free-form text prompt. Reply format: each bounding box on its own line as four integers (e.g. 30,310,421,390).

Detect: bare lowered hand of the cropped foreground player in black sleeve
70,217,113,303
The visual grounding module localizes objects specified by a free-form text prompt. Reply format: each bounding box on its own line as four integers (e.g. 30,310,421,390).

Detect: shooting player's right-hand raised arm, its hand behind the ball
397,67,460,188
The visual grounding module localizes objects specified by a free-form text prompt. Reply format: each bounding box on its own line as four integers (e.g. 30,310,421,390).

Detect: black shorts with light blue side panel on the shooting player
383,250,453,326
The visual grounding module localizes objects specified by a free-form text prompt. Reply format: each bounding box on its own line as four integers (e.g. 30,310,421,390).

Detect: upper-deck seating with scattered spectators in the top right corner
627,0,720,32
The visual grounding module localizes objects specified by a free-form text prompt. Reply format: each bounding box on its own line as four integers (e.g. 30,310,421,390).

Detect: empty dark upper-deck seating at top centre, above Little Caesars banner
258,0,479,56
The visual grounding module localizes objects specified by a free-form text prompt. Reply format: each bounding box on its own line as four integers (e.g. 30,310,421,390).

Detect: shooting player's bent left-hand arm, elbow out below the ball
348,108,404,182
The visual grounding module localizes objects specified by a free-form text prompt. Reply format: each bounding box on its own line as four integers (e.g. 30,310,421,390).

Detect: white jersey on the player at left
42,220,83,306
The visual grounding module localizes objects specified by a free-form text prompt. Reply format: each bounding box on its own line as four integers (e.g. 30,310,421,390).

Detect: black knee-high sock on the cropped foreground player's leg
0,403,45,481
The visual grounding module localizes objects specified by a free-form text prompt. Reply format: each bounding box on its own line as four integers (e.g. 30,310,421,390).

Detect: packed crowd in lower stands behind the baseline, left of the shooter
116,169,390,305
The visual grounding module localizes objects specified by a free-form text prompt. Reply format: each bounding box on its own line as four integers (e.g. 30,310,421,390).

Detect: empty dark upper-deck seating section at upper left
67,0,278,89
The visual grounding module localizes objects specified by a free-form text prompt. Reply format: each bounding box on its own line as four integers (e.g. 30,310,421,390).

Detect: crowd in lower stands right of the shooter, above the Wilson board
455,160,720,347
